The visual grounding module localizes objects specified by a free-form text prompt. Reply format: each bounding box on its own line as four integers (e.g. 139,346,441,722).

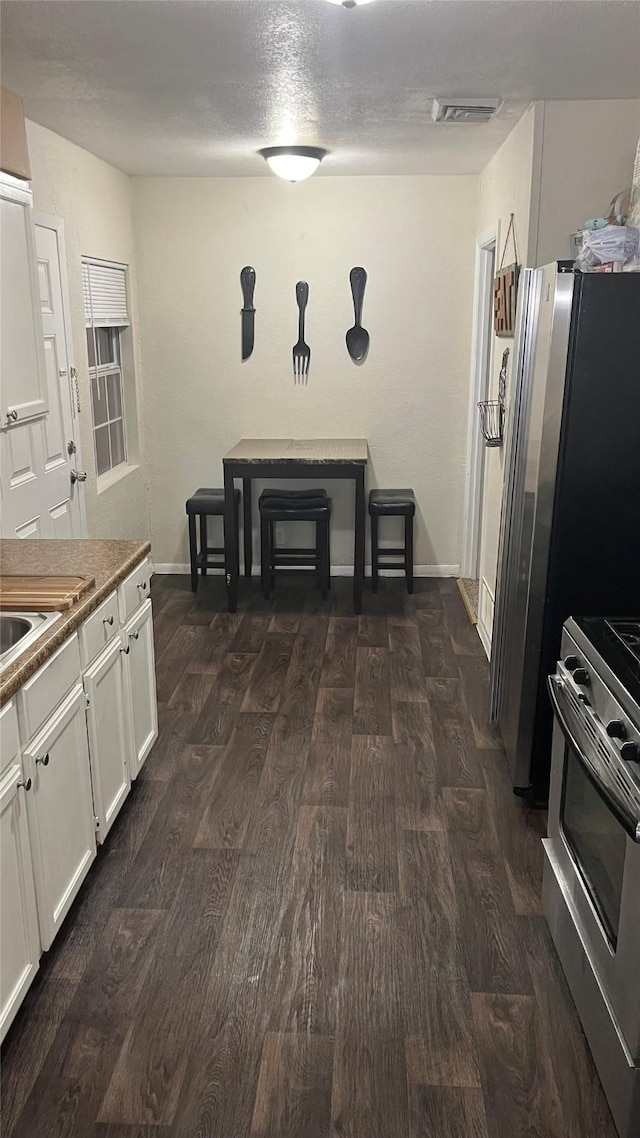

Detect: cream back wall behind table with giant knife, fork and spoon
134,176,477,567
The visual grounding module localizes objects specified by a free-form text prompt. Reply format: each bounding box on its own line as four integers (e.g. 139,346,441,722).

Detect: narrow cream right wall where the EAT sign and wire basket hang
477,105,540,644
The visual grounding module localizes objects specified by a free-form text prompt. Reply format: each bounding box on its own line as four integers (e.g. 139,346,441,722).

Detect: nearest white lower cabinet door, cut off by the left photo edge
0,761,40,1040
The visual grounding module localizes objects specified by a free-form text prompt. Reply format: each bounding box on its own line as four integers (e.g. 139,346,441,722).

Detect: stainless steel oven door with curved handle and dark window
542,675,640,1059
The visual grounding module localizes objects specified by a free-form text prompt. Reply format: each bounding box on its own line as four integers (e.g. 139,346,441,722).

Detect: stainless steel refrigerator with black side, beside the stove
491,262,640,800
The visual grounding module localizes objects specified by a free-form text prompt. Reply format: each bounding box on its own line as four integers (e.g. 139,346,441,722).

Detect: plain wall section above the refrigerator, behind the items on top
531,99,640,265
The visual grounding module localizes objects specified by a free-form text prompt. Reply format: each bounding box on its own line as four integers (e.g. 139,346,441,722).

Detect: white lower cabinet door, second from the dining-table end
84,636,134,842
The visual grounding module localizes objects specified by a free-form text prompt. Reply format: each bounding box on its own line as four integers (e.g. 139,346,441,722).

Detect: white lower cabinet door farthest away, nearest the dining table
122,601,158,778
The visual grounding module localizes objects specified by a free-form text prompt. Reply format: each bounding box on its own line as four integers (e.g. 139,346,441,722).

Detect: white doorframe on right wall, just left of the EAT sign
460,226,498,579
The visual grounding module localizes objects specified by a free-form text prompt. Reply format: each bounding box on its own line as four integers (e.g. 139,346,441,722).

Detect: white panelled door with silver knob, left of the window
34,214,85,537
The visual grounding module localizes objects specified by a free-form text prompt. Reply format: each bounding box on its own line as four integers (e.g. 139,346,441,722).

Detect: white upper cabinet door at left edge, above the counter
0,174,48,427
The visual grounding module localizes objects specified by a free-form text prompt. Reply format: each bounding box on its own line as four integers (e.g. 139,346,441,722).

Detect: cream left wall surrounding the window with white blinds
27,122,149,538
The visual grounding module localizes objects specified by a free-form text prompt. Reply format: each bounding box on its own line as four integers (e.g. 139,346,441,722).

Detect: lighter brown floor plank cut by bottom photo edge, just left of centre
251,1031,334,1138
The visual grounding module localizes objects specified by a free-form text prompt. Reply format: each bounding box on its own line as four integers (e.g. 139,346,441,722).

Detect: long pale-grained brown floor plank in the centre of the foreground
265,806,346,1037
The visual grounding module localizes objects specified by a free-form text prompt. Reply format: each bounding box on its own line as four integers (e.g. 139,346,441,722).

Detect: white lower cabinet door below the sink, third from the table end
23,683,96,949
